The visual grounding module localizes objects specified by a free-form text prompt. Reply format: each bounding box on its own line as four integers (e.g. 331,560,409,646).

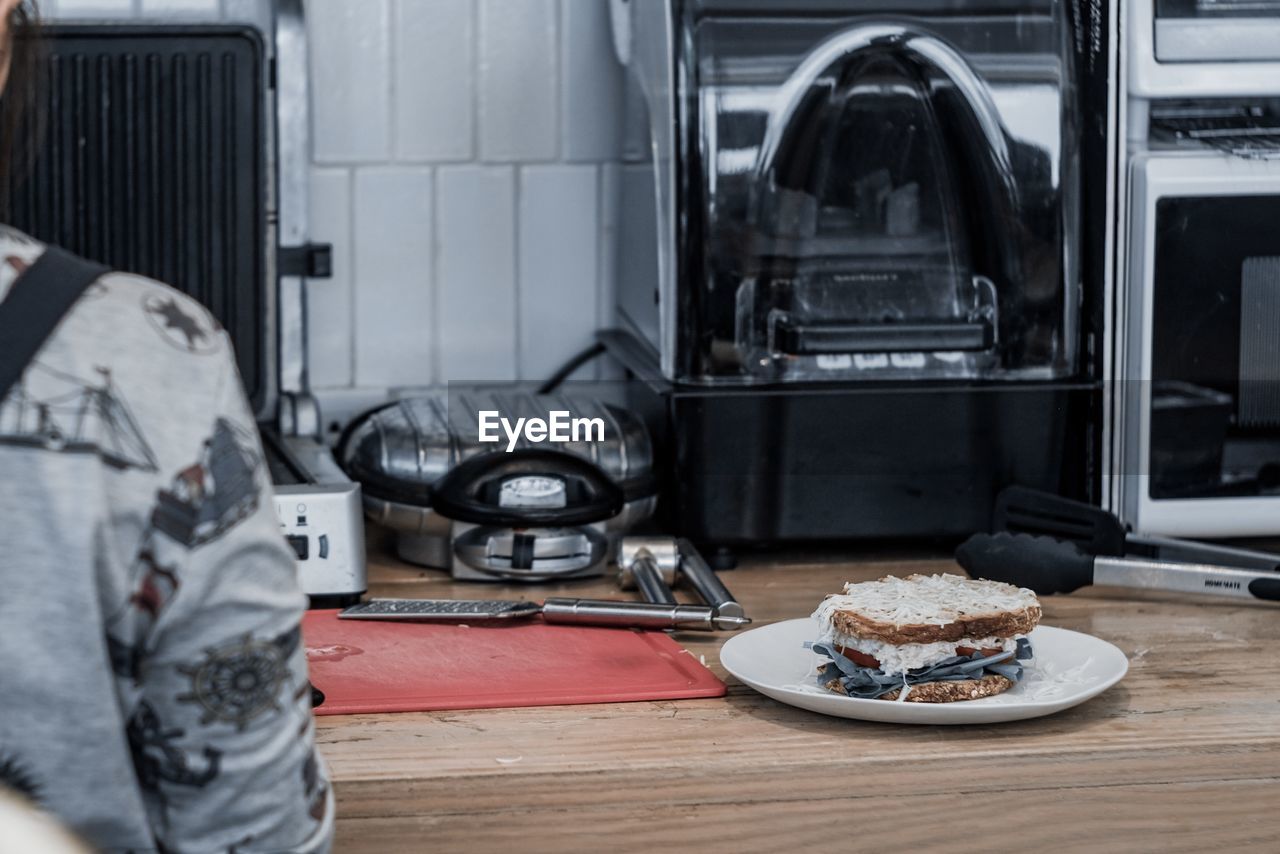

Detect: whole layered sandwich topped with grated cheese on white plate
806,575,1041,703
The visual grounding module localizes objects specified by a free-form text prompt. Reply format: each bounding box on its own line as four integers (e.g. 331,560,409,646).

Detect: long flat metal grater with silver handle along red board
338,598,751,631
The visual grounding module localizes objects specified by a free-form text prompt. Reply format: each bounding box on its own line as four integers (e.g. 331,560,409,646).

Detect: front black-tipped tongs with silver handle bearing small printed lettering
956,534,1280,602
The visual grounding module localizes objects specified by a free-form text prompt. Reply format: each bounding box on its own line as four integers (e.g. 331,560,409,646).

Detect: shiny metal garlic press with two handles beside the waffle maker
618,536,746,617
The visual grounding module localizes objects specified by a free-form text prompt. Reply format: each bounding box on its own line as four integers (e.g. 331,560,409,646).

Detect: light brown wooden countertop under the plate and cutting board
317,537,1280,853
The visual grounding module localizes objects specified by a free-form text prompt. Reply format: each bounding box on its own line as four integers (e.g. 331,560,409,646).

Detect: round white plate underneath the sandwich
721,618,1129,723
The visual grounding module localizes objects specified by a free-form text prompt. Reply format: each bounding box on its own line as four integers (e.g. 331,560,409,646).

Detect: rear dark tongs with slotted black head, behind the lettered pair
992,487,1280,572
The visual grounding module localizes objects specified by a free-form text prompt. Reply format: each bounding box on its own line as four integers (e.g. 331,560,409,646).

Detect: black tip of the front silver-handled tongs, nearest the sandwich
956,534,1093,595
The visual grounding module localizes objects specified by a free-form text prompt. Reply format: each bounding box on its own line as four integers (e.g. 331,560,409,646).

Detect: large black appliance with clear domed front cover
604,0,1111,544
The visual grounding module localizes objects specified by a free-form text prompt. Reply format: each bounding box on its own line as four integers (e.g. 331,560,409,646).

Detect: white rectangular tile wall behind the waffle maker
41,0,632,391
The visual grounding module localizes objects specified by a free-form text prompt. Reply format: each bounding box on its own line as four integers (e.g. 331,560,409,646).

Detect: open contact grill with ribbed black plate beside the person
4,0,365,604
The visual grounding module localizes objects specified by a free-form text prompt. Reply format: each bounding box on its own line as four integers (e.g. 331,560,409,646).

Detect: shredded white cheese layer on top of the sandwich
813,574,1039,639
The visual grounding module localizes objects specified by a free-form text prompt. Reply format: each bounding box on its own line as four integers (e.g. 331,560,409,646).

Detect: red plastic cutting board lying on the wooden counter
302,611,724,714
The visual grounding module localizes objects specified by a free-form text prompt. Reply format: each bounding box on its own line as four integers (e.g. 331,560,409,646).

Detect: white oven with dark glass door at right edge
1110,0,1280,536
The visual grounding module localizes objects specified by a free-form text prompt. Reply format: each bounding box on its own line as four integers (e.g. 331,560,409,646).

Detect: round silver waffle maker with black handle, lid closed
338,388,657,581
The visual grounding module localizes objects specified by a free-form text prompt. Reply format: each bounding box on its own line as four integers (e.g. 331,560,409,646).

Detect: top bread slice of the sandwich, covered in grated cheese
814,574,1042,647
